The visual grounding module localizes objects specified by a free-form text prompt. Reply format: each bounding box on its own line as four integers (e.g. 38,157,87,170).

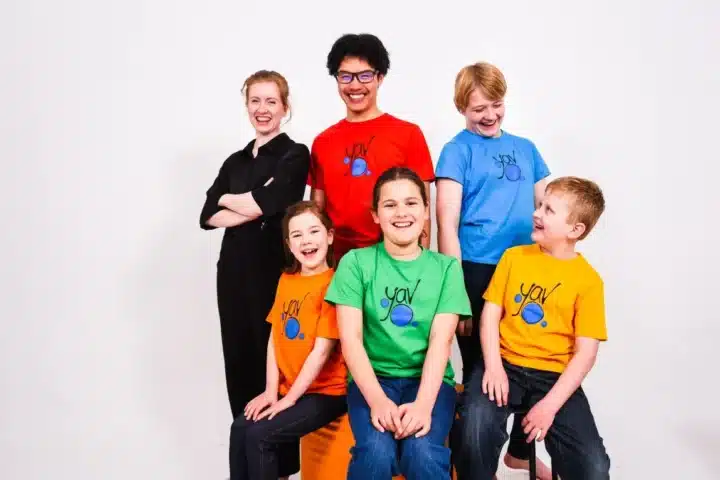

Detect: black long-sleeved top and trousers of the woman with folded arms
200,133,310,418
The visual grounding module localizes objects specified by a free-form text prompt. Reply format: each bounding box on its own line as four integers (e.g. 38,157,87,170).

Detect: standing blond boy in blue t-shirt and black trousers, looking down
435,63,551,480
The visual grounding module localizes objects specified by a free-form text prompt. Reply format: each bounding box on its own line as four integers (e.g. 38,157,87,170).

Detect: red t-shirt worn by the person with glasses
308,113,435,258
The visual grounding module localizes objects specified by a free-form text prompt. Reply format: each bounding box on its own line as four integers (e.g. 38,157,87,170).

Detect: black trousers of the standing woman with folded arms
217,226,300,476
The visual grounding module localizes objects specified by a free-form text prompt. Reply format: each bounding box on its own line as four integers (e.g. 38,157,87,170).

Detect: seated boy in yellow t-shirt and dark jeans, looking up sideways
454,177,610,480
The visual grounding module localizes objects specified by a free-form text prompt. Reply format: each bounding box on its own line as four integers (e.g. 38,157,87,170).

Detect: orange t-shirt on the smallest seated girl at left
267,269,347,395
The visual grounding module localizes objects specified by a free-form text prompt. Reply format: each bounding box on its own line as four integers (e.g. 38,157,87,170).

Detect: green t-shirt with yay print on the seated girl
325,242,471,386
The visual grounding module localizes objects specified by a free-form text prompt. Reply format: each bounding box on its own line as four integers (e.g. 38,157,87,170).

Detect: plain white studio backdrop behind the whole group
0,0,720,480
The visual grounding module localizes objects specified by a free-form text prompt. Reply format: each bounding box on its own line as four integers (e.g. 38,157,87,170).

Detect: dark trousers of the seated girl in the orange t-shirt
230,393,347,480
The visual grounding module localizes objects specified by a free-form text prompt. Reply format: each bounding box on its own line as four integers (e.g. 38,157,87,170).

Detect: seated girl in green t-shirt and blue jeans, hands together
325,167,471,480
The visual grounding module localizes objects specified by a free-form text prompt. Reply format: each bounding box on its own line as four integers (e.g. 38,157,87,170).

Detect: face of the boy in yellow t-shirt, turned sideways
531,191,585,247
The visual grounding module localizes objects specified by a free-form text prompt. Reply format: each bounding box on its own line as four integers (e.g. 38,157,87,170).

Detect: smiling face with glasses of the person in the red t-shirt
335,57,383,114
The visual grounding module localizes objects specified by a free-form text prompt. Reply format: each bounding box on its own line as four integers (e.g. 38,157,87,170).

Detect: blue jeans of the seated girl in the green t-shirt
347,377,456,480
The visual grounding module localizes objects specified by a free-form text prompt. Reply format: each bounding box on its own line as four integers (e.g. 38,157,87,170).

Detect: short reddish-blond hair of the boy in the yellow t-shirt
545,176,605,240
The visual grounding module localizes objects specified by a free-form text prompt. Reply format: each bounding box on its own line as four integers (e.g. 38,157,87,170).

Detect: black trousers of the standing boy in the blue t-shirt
457,261,530,460
